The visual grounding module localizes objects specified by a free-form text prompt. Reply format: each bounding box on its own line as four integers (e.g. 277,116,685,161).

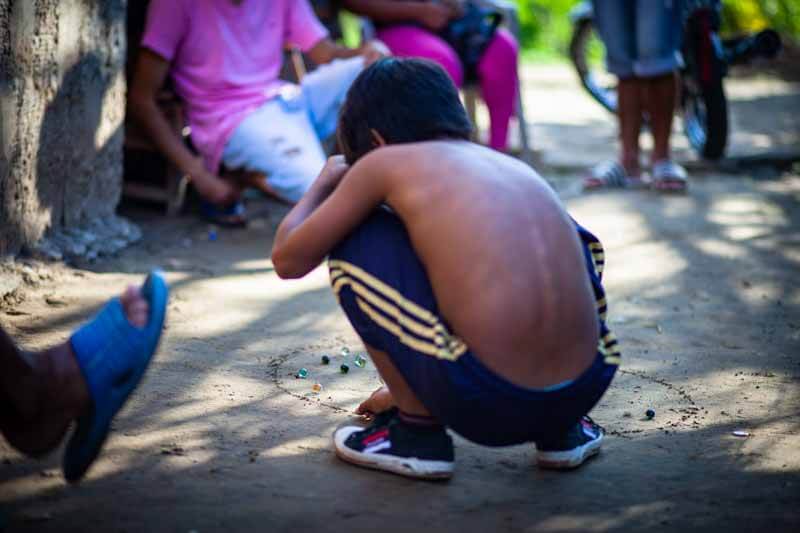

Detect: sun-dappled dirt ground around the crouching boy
0,64,800,532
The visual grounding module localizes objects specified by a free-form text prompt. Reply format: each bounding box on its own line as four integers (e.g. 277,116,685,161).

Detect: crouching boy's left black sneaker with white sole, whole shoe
333,408,455,479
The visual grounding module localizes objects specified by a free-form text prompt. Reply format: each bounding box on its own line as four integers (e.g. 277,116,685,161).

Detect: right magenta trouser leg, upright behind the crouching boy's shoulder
478,28,522,150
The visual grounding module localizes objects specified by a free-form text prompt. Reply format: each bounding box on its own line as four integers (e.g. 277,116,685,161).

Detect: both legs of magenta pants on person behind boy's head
378,26,518,150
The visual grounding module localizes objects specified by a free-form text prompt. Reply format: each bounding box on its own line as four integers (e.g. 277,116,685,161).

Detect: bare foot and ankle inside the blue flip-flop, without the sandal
0,287,148,456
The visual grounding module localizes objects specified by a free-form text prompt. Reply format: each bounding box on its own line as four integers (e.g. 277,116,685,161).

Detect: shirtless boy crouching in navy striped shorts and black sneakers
272,59,620,478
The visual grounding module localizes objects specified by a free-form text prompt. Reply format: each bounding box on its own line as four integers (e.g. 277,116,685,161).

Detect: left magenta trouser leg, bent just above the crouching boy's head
378,26,464,87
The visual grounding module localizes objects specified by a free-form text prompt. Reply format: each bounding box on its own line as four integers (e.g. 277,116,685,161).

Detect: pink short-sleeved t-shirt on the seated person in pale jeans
142,0,327,172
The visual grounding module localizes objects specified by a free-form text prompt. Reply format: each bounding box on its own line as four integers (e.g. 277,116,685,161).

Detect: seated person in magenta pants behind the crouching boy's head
342,0,518,151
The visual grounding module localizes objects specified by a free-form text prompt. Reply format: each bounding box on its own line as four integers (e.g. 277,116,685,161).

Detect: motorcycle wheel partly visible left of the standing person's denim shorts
569,17,617,113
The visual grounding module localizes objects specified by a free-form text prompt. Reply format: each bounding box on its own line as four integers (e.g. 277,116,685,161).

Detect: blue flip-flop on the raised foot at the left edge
63,271,169,483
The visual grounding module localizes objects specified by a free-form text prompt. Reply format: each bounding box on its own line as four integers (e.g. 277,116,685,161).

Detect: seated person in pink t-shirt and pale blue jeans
129,0,382,224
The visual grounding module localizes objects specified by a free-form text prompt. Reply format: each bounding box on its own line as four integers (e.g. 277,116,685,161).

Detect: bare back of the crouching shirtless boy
376,141,598,387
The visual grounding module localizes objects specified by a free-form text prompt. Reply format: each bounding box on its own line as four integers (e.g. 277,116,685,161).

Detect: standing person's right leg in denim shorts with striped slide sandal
634,0,686,191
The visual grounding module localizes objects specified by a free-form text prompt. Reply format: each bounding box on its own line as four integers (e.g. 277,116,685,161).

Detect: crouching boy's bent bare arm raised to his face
272,154,388,279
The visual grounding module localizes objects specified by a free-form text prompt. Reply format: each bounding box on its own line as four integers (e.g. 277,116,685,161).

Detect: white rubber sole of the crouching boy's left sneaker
333,426,454,480
